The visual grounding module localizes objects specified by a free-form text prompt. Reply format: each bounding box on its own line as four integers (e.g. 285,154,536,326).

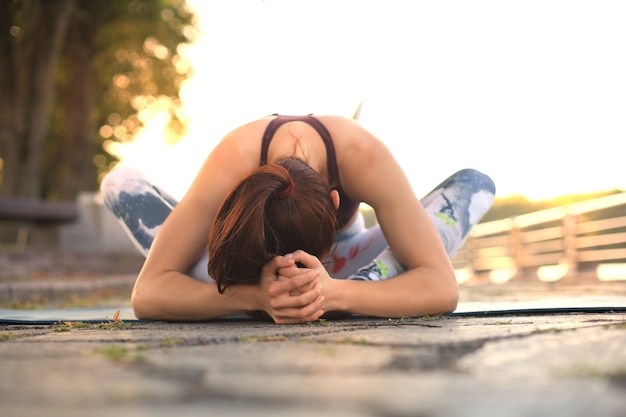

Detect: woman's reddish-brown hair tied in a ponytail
208,157,337,293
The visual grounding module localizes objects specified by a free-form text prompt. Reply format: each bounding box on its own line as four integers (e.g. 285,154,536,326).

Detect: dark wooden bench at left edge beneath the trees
0,198,78,249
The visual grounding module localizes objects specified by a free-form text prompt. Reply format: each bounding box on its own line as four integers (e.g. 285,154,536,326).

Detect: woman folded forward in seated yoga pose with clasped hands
101,115,495,323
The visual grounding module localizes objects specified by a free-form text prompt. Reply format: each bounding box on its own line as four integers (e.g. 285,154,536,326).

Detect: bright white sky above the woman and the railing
112,0,626,199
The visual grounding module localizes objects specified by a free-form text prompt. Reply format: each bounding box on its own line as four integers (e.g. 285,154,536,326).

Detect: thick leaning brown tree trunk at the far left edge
0,0,75,198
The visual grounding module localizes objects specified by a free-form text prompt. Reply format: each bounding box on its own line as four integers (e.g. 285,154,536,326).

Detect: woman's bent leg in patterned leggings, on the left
100,168,212,282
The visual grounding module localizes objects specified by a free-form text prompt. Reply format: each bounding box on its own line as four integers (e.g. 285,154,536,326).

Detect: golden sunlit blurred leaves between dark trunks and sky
60,0,196,184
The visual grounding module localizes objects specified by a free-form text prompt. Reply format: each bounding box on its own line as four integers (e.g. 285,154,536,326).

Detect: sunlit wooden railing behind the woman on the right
452,193,626,283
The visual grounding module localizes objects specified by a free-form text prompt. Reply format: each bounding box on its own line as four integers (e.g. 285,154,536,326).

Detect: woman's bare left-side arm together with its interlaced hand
131,127,321,322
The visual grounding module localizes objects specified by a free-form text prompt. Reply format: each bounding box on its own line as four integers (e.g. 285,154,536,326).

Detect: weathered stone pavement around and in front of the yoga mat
0,250,626,417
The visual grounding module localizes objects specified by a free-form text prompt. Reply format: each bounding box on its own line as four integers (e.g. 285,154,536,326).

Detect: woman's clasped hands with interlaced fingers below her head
259,250,331,324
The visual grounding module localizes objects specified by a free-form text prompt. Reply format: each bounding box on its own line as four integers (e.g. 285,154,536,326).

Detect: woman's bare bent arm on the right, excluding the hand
320,122,458,317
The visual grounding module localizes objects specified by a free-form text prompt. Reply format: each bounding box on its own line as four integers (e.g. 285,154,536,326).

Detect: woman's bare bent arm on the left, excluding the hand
131,128,259,320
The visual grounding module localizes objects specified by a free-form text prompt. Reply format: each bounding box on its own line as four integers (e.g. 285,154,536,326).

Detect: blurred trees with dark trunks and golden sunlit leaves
0,0,195,199
